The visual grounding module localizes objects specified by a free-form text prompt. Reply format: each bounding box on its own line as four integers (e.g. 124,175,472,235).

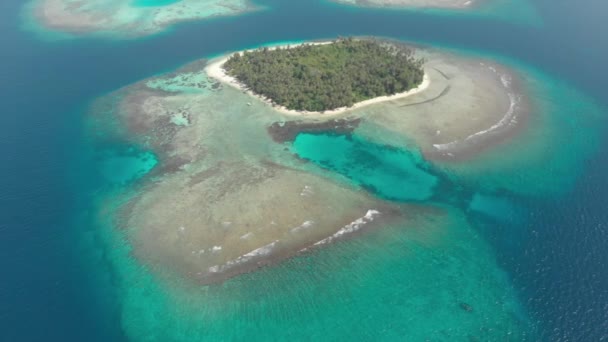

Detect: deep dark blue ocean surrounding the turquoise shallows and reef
0,0,608,341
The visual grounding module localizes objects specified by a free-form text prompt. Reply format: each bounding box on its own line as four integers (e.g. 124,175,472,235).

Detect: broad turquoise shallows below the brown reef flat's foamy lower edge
98,207,537,341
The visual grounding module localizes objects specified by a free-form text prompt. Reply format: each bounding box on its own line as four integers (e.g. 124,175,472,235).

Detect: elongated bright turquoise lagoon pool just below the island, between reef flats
293,133,438,201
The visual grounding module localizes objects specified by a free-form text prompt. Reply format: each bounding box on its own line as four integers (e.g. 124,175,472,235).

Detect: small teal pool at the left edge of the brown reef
98,148,158,185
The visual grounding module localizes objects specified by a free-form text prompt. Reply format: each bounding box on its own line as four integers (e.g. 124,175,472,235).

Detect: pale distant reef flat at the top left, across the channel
25,0,255,38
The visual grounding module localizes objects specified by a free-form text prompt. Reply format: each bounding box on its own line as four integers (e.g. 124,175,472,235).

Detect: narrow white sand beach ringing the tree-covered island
205,42,431,117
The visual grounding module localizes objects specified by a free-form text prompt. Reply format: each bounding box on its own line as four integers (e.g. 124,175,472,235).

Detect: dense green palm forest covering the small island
224,38,424,111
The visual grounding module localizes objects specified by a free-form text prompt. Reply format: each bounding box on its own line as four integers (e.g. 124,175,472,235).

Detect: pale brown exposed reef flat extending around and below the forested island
97,42,527,283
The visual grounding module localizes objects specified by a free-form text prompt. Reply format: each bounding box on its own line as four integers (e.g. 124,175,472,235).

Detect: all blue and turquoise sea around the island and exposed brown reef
0,0,608,341
